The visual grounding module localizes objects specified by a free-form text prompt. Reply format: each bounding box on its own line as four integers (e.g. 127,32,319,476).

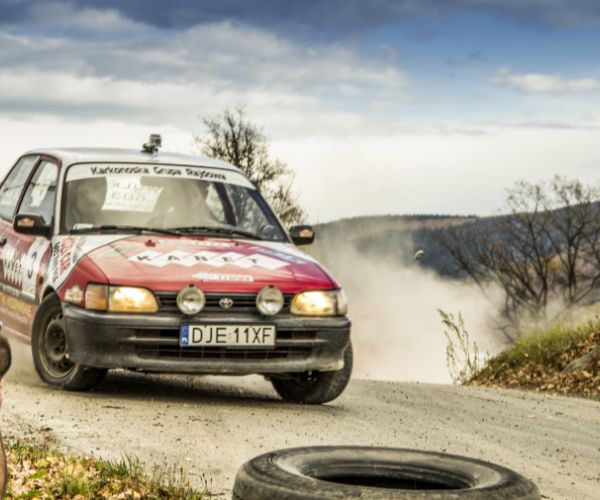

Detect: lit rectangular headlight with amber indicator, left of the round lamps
85,284,158,313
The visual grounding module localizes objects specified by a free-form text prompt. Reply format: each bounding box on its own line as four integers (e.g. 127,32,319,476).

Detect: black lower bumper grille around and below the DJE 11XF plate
134,329,317,360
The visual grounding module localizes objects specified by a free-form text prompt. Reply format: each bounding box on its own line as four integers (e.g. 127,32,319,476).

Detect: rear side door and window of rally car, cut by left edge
0,155,39,333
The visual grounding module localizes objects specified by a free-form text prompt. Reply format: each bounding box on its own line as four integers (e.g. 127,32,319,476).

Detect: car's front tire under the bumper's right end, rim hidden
271,344,353,405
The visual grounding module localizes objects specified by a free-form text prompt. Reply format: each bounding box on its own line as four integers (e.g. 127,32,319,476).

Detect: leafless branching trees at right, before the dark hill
438,177,600,340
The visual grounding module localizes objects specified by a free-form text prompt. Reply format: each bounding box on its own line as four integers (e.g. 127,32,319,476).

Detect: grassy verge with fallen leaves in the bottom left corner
4,439,209,500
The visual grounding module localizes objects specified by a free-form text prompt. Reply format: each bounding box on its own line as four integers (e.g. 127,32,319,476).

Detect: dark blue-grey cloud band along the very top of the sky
0,0,600,39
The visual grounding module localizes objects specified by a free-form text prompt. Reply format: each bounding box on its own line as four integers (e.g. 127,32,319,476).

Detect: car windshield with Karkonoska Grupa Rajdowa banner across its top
61,164,286,241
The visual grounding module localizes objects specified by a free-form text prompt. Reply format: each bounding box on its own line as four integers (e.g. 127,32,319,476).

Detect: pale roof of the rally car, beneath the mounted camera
25,148,241,172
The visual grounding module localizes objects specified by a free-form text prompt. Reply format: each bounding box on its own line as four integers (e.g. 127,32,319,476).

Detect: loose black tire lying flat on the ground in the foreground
233,446,540,500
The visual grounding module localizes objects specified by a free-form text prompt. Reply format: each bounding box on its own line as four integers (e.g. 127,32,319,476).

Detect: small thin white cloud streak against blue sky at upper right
491,68,600,94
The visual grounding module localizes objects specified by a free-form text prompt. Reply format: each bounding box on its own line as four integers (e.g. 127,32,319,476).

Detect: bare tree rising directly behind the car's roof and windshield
194,107,305,224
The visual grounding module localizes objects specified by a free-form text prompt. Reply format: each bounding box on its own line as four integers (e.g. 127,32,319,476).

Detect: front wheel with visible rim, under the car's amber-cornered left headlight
31,295,107,391
